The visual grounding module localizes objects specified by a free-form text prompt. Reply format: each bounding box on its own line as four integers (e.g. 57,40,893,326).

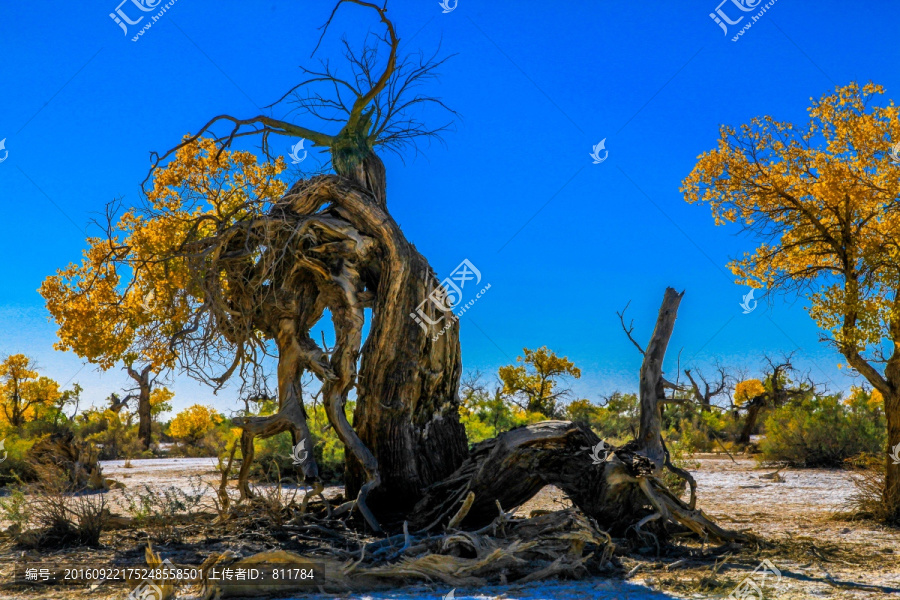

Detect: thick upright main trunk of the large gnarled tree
330,143,467,515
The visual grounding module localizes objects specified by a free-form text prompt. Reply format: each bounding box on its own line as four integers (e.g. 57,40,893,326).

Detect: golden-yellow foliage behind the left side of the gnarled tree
39,139,286,372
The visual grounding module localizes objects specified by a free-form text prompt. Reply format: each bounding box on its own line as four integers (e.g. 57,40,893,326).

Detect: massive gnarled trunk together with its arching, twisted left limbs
241,164,467,528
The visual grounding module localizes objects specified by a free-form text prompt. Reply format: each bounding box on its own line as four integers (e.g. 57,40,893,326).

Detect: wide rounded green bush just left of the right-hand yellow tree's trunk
760,395,886,467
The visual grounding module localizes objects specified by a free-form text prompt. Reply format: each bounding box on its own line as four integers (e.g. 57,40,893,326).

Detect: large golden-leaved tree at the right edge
682,83,900,520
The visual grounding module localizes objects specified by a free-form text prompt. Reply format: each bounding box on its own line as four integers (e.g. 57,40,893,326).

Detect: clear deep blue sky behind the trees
0,0,888,410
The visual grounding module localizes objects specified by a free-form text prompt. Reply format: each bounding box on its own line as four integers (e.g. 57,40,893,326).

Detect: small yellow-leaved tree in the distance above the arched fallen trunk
498,346,581,418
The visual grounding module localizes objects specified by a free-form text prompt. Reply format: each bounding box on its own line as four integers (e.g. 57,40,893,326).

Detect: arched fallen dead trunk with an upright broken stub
410,288,744,540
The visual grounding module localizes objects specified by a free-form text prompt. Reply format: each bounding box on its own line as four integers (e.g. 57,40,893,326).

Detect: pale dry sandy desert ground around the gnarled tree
0,455,900,600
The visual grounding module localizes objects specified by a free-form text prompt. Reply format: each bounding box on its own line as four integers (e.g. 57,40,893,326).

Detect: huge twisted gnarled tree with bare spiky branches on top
136,0,466,529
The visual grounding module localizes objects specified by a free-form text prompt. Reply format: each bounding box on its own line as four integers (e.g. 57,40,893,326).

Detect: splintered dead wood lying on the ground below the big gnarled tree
189,510,615,600
